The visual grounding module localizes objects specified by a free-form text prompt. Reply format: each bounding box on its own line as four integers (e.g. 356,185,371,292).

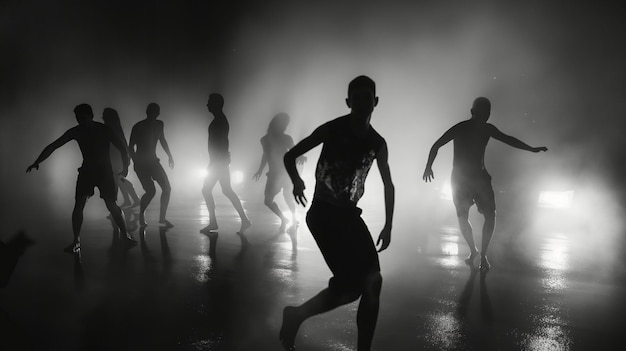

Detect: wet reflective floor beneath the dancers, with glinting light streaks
0,200,626,350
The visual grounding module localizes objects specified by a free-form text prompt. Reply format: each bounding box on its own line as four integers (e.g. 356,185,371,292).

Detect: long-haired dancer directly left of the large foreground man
253,113,306,233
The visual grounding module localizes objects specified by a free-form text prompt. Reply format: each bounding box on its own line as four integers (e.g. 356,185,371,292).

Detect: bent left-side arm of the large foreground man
283,124,328,206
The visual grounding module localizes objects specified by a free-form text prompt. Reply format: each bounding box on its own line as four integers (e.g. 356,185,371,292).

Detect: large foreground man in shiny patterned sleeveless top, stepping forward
279,76,394,351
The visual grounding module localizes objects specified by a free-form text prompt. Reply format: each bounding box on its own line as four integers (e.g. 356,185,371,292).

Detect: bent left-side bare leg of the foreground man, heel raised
278,288,359,350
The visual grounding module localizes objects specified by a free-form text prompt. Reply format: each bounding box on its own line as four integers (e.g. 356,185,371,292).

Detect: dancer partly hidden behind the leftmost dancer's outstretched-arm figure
102,107,139,208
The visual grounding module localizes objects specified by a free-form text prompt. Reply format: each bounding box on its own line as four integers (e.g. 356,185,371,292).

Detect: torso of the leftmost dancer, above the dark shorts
68,121,114,169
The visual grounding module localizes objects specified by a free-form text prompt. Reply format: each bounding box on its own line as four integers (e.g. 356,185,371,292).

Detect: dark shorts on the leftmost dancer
76,166,117,201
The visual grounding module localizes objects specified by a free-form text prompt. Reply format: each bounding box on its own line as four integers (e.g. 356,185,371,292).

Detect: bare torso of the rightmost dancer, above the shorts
452,120,493,176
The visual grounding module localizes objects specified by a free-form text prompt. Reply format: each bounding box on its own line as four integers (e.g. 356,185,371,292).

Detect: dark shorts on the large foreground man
306,200,380,292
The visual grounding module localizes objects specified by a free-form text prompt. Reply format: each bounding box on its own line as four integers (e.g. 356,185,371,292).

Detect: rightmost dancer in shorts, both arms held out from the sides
423,97,548,270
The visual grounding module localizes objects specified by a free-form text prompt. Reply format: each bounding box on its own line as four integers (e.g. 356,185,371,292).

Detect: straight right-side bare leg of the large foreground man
356,272,383,351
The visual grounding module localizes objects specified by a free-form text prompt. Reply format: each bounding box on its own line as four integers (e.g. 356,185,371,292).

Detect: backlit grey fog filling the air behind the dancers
0,1,626,256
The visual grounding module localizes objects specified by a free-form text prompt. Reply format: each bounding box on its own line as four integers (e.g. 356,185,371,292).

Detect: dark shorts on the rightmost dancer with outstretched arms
452,171,496,213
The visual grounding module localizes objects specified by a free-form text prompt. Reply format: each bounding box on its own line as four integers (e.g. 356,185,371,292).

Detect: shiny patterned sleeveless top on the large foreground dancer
314,116,385,207
